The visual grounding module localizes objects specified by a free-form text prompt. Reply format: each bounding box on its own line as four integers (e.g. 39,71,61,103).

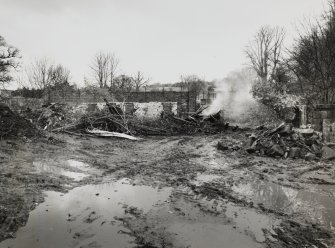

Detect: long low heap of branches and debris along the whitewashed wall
16,99,234,140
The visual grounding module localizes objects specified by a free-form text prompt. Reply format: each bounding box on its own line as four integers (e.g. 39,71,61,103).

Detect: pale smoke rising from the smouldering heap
205,69,256,121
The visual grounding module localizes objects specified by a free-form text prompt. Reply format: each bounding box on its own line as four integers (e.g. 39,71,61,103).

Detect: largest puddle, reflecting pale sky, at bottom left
0,180,171,248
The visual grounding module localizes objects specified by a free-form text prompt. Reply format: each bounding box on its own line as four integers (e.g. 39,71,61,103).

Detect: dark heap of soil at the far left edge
0,103,37,138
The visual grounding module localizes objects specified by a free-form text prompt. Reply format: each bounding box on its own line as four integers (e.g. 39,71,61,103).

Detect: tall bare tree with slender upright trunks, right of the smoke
245,26,285,82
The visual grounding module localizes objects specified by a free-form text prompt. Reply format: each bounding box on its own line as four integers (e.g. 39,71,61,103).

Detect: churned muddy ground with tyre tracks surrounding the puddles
0,134,334,247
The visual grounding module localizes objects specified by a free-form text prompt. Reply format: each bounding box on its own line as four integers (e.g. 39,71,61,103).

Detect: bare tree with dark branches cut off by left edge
0,35,20,91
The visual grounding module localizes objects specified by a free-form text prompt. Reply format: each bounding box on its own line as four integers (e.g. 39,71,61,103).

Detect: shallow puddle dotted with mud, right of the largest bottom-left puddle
169,190,280,247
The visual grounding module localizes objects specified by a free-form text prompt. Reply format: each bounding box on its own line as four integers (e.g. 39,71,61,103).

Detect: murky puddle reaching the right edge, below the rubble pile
232,181,335,230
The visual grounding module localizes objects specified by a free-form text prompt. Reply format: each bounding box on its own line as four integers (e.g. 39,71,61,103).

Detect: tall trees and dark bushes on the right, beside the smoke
245,1,335,112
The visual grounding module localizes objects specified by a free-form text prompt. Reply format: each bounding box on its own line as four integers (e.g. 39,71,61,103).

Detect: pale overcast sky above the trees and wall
0,0,328,85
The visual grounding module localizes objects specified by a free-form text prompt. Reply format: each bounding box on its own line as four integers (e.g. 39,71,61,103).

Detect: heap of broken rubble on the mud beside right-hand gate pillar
247,123,324,160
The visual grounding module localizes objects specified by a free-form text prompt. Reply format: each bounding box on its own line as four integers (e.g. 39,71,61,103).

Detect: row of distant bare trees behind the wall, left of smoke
0,42,207,101
